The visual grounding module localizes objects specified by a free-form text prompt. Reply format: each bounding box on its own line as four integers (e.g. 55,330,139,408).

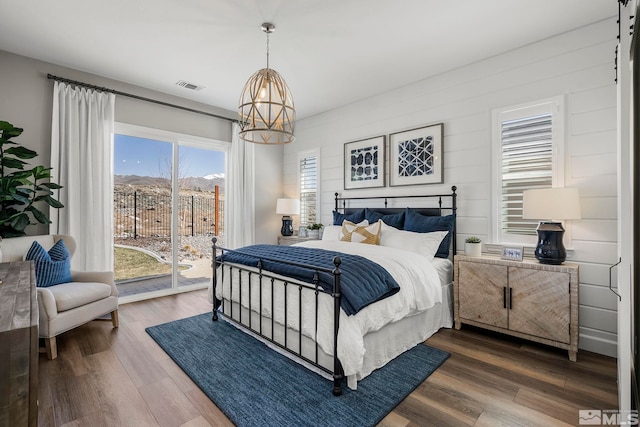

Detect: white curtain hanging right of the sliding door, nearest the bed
224,123,255,249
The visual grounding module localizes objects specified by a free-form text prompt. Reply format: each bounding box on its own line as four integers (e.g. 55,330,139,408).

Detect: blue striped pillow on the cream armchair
25,240,71,288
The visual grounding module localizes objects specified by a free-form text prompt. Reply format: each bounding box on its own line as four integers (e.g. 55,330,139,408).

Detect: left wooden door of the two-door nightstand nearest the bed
458,261,509,329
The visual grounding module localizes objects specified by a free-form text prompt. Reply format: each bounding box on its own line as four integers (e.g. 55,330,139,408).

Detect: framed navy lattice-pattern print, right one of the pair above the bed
389,123,444,187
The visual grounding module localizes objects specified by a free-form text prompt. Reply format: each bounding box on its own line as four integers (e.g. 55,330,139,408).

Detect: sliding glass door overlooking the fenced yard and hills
113,125,227,299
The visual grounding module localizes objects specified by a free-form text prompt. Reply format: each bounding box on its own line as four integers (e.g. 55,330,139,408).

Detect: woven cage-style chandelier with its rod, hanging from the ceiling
238,23,296,144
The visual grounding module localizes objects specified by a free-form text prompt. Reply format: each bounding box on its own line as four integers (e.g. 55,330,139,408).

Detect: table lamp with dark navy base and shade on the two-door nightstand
522,188,582,265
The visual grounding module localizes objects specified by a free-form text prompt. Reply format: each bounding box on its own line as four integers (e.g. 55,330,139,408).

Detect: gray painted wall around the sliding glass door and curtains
0,51,283,243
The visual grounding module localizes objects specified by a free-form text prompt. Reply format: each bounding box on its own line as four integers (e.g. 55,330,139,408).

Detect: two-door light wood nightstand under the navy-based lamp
453,255,579,362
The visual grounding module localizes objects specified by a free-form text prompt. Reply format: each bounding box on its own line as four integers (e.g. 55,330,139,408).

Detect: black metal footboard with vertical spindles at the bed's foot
212,237,344,396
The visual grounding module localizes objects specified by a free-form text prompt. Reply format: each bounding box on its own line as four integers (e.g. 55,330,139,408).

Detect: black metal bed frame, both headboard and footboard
212,186,457,396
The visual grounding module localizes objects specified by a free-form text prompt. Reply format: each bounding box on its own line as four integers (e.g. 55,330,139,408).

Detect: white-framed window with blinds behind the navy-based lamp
492,97,564,244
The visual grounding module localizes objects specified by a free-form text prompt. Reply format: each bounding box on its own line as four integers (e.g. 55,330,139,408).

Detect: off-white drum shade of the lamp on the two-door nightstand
522,188,582,220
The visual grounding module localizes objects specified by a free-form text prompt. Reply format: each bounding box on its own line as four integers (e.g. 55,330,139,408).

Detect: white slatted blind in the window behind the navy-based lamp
501,113,553,235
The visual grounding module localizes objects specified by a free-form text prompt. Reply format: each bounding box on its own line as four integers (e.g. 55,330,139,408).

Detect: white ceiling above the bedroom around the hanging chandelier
0,0,618,119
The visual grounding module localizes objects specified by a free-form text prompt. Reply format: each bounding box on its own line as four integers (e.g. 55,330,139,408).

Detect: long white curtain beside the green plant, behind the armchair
50,82,115,271
